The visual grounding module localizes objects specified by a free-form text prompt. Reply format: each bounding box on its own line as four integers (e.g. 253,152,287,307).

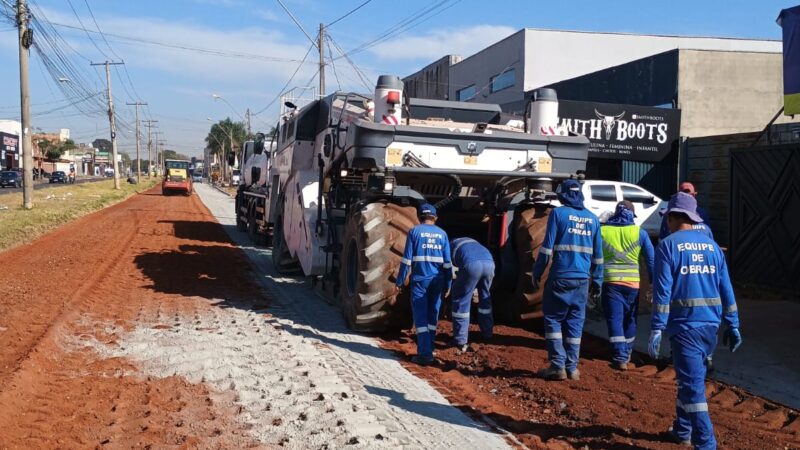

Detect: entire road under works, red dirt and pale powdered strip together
0,184,800,449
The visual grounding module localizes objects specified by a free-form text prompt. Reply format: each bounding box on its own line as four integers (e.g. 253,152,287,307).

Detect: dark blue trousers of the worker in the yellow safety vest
603,283,639,363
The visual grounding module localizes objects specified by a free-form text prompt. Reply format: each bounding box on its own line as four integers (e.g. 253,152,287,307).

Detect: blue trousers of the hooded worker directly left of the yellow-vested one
542,278,589,372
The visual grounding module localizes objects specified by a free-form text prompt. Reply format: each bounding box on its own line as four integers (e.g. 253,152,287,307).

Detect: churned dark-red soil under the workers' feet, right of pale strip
383,321,800,450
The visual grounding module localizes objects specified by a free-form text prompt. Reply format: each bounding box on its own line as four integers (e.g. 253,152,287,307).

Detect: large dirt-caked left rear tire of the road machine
339,201,419,332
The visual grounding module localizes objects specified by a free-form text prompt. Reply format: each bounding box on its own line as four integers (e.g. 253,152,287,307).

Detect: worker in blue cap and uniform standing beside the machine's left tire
396,203,453,365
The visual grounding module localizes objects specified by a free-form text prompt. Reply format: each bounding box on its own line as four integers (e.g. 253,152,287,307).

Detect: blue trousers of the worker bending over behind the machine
451,261,494,345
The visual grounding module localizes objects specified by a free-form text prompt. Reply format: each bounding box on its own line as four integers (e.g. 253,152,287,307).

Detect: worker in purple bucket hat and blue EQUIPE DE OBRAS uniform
648,192,742,449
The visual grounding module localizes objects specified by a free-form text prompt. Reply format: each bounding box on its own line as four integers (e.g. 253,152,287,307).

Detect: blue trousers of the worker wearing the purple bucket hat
669,325,717,450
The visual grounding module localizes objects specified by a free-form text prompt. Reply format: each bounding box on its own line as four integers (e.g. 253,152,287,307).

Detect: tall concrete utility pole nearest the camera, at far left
17,0,33,209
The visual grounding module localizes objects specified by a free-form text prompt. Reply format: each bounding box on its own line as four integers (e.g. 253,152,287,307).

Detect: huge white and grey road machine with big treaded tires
236,75,589,331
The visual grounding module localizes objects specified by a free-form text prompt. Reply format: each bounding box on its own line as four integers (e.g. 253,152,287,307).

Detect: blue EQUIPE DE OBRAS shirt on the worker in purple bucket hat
651,230,739,336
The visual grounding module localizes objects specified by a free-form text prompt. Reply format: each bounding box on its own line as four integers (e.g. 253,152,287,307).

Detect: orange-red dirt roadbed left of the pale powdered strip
0,188,266,448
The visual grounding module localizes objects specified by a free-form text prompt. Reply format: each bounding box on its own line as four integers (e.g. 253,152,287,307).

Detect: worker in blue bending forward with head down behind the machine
450,237,494,352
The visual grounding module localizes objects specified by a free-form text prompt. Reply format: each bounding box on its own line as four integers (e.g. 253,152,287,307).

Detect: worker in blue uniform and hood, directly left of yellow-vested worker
533,180,603,380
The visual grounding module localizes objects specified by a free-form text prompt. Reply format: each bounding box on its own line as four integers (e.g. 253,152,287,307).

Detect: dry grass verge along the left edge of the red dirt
0,178,158,250
